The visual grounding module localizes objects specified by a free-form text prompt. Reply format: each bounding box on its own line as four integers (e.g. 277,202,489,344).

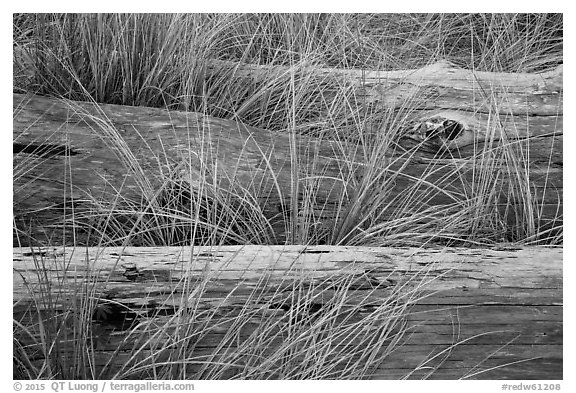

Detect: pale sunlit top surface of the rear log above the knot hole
207,61,564,117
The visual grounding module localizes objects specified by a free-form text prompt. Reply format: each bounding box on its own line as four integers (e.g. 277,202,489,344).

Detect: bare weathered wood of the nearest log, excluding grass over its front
13,246,563,379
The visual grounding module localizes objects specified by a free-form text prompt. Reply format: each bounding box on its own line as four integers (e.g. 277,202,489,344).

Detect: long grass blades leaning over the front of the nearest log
14,248,426,379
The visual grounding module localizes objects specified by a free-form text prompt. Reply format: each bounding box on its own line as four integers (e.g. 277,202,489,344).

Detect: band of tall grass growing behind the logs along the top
14,14,563,118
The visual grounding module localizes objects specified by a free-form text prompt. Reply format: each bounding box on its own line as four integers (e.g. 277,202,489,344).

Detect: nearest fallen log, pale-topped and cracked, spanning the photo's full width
13,246,563,380
